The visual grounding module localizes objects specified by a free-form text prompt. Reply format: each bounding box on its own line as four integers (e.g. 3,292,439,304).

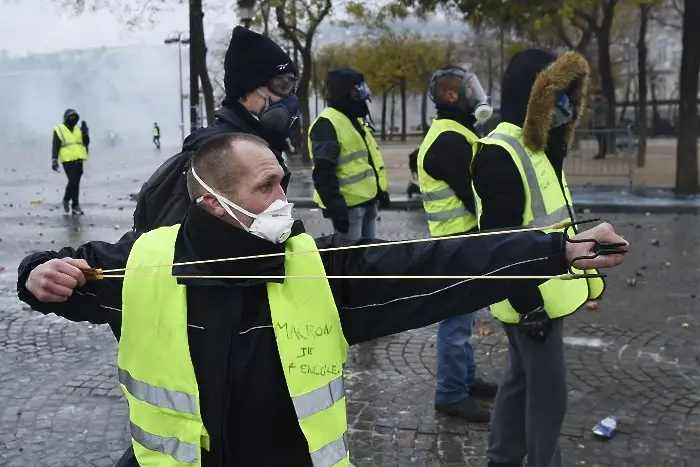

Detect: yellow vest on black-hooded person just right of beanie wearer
309,107,389,209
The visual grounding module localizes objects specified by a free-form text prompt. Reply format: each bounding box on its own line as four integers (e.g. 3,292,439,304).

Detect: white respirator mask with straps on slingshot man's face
191,167,294,243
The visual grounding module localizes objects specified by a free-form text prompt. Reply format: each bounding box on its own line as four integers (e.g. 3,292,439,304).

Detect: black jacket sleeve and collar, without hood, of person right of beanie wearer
309,103,380,217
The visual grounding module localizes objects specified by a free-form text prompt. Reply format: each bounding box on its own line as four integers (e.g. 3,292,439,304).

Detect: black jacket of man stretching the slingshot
17,206,566,467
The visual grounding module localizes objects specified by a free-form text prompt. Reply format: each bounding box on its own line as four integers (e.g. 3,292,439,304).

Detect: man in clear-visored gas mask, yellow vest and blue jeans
418,66,498,423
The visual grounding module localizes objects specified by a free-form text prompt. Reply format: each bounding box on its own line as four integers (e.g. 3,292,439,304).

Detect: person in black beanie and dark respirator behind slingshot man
134,26,299,232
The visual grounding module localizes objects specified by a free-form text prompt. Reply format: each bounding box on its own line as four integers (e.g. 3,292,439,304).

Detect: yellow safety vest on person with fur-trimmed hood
472,122,605,323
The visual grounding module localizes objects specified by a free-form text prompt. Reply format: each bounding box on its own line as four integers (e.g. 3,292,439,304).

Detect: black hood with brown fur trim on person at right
501,49,590,151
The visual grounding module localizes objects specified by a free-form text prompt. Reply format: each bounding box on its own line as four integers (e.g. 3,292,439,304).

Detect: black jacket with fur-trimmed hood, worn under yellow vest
472,51,587,313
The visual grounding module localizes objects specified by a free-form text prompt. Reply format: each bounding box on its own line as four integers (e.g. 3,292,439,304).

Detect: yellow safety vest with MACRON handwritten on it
118,225,350,467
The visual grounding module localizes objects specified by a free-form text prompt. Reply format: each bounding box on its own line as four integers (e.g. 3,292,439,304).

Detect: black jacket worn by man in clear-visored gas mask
423,104,476,227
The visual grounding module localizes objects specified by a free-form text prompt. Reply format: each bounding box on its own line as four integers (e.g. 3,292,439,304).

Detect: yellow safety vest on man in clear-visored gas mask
418,118,478,237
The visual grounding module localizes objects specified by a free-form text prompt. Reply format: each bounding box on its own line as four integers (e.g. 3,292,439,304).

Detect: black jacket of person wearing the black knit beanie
134,102,291,232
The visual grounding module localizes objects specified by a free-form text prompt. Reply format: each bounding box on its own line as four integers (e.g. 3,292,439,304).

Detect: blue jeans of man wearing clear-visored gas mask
435,312,476,404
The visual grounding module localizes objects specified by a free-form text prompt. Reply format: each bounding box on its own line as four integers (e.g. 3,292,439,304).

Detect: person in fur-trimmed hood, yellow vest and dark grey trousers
472,49,604,467
